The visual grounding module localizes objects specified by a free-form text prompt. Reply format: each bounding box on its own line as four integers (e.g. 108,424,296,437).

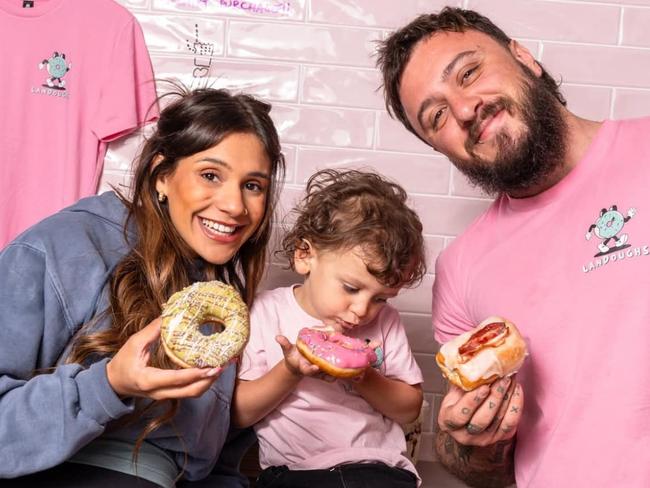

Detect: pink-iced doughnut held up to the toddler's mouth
296,327,384,378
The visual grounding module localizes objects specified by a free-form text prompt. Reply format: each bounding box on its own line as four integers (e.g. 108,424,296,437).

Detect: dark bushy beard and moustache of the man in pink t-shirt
450,68,566,195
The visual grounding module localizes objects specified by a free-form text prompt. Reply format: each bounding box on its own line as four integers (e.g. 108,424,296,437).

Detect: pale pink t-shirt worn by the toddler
239,287,422,475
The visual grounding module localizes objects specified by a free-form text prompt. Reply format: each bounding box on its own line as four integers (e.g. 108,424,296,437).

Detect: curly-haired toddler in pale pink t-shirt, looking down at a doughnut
232,170,425,488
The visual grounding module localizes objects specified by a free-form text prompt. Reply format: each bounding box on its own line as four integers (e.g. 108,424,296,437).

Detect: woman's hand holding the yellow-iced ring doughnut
106,318,223,400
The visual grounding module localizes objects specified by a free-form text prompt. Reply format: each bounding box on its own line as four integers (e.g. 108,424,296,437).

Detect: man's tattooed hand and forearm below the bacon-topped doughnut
436,378,524,488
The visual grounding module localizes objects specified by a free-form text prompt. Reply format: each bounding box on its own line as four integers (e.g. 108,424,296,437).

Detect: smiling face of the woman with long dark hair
156,133,271,264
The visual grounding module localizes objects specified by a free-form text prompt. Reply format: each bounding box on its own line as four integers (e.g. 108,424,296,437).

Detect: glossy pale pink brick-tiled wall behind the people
101,0,650,459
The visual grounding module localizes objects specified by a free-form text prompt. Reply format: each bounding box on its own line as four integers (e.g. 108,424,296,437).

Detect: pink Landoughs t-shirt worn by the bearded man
433,119,650,488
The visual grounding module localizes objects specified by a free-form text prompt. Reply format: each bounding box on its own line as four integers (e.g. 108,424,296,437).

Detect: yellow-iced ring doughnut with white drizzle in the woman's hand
160,281,249,368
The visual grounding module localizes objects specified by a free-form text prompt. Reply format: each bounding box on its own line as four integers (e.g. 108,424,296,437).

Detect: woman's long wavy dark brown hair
68,87,284,452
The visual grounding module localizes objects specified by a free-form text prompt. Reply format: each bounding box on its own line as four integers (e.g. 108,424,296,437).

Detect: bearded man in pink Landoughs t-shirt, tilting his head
378,8,650,488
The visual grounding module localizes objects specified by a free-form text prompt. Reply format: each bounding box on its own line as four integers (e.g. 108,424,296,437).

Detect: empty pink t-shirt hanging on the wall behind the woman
0,0,157,248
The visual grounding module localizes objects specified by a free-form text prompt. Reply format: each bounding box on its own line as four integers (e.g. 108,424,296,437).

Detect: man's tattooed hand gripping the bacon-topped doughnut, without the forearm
438,377,524,446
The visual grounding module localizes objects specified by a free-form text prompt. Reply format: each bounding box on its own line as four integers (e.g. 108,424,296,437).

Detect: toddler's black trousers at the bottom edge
255,463,417,488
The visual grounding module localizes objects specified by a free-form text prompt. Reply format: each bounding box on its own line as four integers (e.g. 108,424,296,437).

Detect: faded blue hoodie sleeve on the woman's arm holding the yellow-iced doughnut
0,243,132,478
